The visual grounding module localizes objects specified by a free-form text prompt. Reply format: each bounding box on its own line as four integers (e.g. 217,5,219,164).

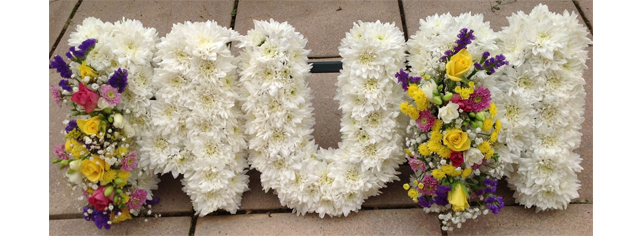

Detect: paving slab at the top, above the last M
402,0,584,33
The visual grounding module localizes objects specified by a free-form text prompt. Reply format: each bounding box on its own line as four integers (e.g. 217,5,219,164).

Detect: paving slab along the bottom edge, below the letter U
195,209,441,235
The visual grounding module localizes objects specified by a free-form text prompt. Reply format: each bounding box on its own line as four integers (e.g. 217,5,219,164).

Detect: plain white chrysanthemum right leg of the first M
141,21,249,216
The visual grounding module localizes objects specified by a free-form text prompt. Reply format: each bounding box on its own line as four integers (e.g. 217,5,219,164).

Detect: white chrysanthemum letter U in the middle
240,20,405,217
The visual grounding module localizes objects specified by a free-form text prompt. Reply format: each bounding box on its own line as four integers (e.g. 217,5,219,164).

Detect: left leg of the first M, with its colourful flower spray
50,18,159,229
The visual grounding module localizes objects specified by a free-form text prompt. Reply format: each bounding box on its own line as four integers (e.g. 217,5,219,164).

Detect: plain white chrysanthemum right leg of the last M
497,4,590,211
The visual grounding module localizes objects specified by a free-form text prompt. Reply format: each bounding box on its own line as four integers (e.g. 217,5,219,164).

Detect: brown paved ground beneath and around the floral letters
49,0,593,235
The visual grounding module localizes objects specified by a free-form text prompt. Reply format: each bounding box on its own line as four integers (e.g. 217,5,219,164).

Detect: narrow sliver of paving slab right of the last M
573,46,593,202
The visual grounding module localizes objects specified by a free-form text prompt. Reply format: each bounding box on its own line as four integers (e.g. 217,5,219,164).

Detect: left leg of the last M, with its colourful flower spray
396,12,507,231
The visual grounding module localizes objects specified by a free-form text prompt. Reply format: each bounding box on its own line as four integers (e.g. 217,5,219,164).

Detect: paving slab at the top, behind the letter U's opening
235,0,402,58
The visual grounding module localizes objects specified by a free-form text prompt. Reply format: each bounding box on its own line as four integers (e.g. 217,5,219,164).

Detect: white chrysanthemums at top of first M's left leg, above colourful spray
68,17,158,138
